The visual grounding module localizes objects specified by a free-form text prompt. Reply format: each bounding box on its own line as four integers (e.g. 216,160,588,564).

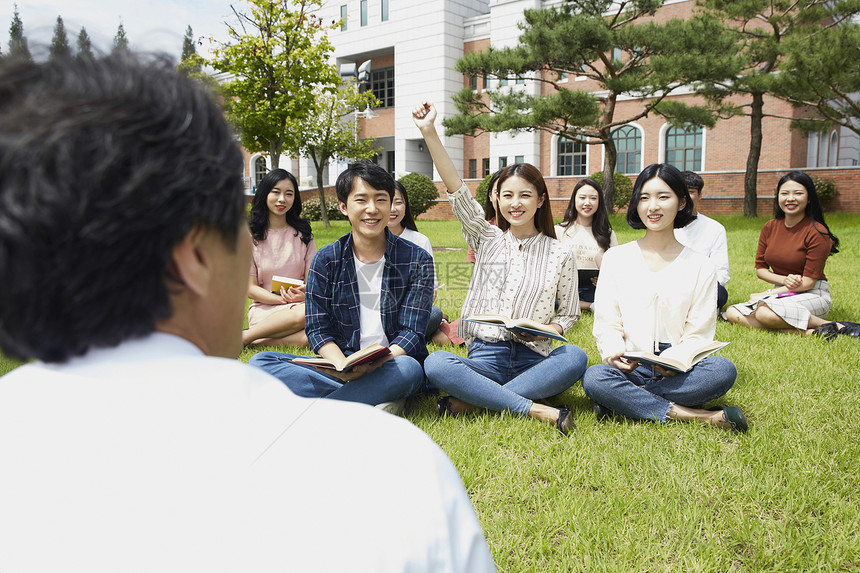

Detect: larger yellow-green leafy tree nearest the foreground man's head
211,0,339,168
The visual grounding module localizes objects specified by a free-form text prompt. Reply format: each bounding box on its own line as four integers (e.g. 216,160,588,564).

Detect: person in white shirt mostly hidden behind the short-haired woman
675,171,729,308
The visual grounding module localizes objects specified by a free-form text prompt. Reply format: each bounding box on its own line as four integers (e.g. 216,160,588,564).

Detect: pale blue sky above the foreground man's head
0,0,235,59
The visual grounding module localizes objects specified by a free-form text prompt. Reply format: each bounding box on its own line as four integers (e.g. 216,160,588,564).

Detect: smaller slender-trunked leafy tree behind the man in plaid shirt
298,82,379,227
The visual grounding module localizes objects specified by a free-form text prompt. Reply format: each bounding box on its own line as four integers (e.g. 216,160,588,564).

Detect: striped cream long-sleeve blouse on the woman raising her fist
448,184,576,356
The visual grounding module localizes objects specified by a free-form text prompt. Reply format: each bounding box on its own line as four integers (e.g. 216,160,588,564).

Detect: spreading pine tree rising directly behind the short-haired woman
443,0,735,205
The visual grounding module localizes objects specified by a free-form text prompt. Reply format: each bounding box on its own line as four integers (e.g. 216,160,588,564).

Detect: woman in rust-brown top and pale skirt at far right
726,171,860,338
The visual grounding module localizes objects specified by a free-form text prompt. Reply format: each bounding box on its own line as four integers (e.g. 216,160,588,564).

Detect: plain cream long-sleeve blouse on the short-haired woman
592,241,717,360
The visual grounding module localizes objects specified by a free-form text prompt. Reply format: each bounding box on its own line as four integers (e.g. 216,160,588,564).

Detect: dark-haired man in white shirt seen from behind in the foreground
0,53,493,572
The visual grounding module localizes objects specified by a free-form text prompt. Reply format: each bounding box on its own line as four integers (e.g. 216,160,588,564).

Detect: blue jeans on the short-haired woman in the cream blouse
582,350,738,422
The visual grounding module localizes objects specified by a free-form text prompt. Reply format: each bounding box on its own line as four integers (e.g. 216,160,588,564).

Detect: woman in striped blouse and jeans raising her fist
412,102,588,434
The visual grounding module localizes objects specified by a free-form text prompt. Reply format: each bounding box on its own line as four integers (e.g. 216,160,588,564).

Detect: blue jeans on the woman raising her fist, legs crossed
424,339,588,416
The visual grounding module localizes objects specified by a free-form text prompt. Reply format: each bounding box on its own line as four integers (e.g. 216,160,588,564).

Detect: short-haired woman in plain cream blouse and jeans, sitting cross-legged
582,163,747,432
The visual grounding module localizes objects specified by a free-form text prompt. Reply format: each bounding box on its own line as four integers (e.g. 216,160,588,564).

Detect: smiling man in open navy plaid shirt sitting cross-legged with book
250,160,434,412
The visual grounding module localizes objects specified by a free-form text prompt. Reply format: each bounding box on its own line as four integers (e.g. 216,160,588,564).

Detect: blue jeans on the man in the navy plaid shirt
248,352,424,406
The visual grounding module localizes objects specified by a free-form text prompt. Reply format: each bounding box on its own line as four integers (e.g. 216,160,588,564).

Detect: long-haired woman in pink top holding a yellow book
242,169,317,346
